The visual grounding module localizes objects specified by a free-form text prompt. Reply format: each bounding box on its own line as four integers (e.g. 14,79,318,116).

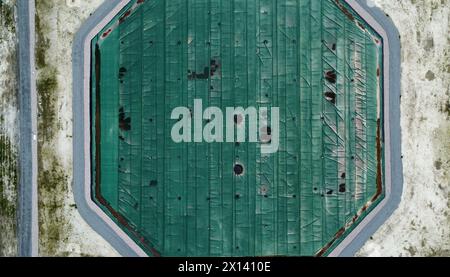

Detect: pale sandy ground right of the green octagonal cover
358,0,450,256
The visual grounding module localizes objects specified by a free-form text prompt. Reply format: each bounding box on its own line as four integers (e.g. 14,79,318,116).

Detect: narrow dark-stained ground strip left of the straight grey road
0,0,19,256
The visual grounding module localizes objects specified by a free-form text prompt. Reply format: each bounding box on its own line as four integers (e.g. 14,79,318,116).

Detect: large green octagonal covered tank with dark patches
72,0,402,256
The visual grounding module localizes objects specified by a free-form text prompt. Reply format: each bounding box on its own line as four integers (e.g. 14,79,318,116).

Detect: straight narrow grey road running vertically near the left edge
17,0,38,257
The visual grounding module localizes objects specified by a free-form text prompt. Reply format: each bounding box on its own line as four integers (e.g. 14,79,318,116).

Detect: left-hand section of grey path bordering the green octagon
72,0,146,257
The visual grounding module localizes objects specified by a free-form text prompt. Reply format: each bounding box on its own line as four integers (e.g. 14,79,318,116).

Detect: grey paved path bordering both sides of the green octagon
73,0,403,256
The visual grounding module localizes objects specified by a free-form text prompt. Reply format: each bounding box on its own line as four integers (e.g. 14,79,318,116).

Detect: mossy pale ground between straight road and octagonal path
36,0,118,256
